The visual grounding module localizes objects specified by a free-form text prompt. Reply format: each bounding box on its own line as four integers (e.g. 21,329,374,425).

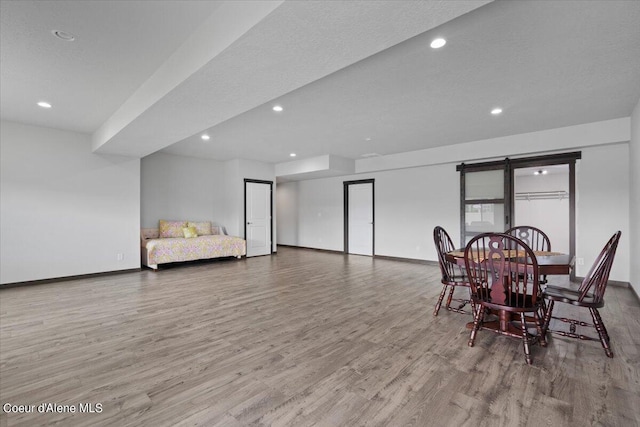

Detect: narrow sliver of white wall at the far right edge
627,100,640,295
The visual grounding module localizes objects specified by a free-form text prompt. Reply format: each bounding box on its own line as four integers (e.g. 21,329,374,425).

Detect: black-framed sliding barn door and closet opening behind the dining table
457,151,582,279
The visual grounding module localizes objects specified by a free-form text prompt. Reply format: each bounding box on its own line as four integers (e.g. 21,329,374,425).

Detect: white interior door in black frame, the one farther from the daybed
348,182,373,256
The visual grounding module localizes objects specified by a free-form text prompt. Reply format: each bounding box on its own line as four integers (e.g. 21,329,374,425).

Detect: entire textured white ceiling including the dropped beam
0,0,640,168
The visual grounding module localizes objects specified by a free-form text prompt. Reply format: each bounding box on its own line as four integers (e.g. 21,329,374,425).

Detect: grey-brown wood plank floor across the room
0,248,640,427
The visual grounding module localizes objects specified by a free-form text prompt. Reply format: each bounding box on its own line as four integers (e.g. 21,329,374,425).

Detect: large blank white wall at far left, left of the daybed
0,121,140,284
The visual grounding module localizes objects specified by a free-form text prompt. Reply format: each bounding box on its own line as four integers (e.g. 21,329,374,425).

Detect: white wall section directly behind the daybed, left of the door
140,152,227,228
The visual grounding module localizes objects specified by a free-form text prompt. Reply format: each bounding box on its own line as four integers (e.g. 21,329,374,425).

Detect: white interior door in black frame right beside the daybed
245,181,271,257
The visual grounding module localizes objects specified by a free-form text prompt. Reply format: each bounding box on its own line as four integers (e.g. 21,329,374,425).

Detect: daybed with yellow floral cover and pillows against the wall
140,220,247,270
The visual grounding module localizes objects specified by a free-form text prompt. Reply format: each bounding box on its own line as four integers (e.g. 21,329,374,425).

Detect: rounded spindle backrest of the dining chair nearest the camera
464,233,540,308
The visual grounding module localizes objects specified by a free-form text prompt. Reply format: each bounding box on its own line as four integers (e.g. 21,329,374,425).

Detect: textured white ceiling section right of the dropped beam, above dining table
165,1,640,162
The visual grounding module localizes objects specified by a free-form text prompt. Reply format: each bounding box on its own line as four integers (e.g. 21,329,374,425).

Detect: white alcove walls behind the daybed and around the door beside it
140,156,277,250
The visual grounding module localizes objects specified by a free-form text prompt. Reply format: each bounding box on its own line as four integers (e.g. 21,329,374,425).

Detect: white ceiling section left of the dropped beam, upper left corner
0,0,217,133
